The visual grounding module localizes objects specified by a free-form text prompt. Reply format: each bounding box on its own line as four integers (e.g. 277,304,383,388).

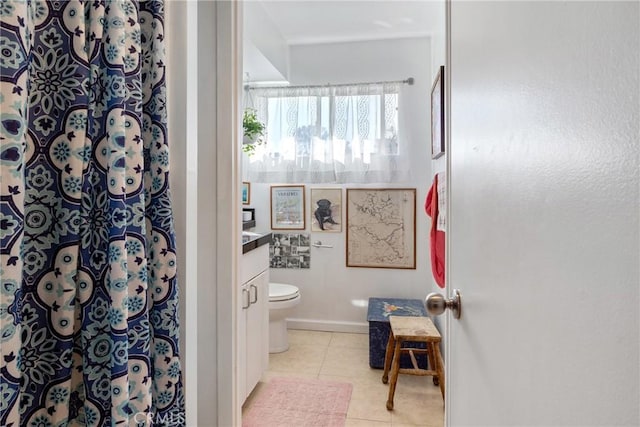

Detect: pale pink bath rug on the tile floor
242,377,353,427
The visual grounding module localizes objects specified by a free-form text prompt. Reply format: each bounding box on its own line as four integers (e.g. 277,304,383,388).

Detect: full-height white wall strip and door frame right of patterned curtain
166,0,242,427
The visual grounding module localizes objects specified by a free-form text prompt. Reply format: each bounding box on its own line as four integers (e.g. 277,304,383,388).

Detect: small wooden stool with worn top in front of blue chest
382,316,444,410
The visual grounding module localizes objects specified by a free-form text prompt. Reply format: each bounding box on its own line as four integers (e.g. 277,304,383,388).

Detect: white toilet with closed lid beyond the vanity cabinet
269,283,300,353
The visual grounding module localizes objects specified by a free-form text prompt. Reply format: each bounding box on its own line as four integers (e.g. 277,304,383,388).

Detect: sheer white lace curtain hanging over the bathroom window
245,83,408,183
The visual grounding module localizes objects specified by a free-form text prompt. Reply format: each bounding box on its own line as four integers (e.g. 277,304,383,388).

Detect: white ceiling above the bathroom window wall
261,0,439,45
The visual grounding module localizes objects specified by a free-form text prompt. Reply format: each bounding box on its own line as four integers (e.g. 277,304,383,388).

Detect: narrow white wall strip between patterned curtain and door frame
165,1,199,426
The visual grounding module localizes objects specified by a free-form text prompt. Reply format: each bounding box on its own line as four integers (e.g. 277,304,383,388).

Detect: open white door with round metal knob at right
446,1,640,426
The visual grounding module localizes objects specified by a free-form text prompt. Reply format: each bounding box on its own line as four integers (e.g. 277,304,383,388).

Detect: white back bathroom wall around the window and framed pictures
242,38,432,332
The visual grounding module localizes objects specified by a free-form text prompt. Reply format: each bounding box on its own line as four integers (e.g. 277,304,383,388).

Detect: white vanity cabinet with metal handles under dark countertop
238,244,269,402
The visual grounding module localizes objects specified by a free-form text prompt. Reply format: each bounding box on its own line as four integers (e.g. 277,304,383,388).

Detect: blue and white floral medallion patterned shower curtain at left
0,0,184,426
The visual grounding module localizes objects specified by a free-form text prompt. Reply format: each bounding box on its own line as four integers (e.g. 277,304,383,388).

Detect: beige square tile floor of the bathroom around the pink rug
243,330,444,427
